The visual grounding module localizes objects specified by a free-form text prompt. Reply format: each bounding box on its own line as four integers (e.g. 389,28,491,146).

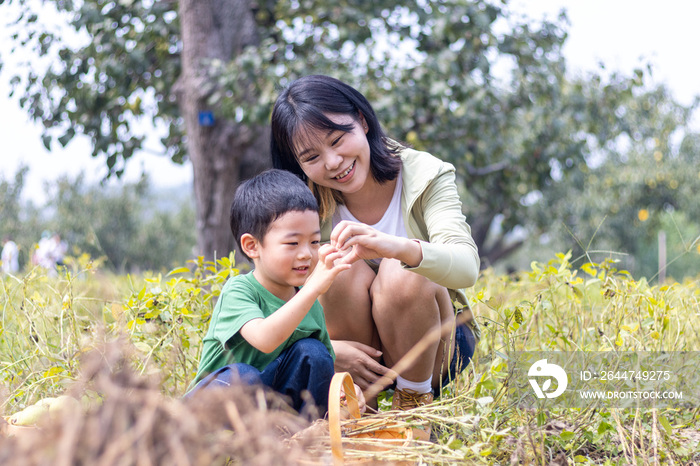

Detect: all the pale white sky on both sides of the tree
0,0,700,204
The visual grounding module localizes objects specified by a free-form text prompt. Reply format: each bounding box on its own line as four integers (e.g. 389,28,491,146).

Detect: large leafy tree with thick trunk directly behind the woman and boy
2,0,696,270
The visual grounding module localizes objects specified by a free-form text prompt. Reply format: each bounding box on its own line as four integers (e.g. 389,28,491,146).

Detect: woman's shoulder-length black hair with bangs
270,75,401,183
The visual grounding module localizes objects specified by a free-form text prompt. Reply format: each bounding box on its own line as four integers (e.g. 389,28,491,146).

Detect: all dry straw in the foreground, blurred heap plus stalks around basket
0,322,472,466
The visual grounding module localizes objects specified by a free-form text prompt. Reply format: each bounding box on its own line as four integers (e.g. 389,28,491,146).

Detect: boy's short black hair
229,168,318,259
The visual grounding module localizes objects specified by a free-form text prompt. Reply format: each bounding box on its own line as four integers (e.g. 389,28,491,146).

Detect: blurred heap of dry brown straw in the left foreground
0,341,318,466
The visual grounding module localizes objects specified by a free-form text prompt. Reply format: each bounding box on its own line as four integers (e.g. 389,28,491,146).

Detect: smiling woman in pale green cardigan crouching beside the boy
271,76,479,409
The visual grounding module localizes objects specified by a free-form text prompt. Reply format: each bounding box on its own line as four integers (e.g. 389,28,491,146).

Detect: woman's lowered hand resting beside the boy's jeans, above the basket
331,340,396,391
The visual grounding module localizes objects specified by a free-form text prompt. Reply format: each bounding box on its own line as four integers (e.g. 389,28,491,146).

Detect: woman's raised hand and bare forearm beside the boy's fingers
331,220,423,267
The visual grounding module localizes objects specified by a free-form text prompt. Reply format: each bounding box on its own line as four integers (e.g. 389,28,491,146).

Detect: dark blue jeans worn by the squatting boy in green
186,338,334,416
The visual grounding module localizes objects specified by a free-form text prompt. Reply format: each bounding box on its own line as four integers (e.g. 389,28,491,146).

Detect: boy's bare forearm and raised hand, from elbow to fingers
240,244,351,353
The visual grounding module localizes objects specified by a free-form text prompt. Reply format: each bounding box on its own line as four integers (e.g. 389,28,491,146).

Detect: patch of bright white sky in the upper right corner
509,0,700,104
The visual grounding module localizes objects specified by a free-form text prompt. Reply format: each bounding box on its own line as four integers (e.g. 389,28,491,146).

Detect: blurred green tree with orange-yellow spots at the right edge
535,82,700,279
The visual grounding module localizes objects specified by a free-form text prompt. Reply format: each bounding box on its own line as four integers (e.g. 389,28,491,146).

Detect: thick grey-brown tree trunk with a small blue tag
175,0,269,260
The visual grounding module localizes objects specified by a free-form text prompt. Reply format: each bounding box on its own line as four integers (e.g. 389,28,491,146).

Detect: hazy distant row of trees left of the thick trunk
0,167,196,273
